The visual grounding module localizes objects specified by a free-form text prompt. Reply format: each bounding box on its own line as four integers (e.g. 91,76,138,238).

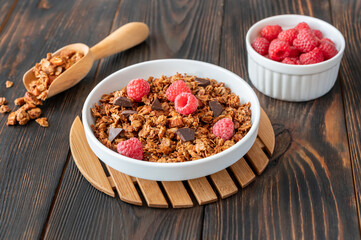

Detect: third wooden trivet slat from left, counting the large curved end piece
137,178,168,208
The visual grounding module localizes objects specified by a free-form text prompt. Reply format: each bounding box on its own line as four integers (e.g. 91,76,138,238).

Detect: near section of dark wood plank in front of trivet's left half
44,158,203,239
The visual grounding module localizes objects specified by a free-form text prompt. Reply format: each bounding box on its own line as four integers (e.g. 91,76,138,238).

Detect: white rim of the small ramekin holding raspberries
246,14,346,75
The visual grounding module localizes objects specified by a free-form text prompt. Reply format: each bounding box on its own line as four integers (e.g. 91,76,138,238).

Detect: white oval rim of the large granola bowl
82,58,261,168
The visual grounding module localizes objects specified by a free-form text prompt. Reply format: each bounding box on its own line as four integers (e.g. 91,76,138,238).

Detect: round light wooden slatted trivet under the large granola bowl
70,109,275,208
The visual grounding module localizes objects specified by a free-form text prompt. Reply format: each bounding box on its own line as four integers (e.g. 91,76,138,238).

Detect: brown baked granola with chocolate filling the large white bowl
91,74,251,162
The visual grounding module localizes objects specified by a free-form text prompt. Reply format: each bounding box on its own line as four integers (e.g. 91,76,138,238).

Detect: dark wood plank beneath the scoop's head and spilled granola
0,0,118,239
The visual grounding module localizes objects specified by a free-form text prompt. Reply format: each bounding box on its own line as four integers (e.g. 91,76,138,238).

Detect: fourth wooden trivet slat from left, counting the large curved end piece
162,182,193,208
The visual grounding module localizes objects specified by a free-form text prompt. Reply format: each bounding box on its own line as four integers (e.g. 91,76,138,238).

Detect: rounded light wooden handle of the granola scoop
90,22,149,60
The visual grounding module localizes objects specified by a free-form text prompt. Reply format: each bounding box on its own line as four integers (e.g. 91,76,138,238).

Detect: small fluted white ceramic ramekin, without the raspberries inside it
246,15,345,101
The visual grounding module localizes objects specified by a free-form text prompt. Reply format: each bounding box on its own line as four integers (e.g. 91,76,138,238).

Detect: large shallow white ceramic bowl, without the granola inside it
82,59,260,181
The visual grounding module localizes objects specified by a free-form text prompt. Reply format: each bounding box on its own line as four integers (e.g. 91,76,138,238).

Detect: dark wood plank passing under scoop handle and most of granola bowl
44,0,223,239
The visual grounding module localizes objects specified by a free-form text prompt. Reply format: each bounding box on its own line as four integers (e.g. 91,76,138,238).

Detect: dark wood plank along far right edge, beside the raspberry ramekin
330,0,361,231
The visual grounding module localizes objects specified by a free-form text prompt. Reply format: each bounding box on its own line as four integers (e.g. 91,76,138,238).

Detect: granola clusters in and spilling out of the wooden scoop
0,49,83,127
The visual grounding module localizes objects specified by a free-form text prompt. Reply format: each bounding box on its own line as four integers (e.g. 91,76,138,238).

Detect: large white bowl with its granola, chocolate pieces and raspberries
82,59,260,181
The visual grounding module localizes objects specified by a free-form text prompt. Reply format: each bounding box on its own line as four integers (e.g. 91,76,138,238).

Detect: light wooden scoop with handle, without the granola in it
23,22,149,98
